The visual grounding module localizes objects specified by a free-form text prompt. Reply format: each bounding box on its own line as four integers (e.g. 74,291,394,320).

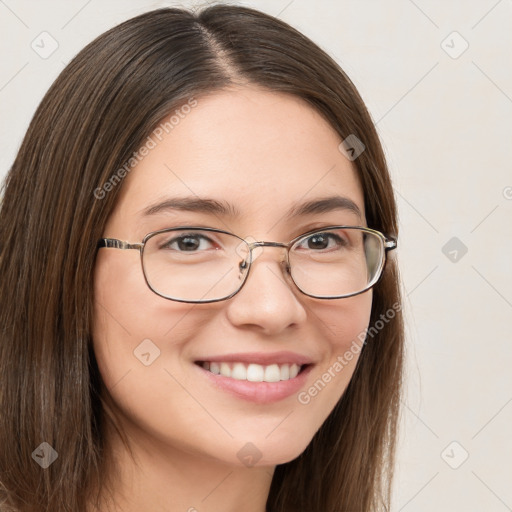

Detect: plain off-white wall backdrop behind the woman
0,0,512,512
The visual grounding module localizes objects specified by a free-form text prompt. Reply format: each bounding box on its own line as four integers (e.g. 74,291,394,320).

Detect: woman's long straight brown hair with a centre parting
0,5,403,512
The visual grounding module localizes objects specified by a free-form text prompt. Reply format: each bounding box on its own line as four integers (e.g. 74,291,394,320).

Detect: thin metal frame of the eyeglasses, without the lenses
97,225,397,304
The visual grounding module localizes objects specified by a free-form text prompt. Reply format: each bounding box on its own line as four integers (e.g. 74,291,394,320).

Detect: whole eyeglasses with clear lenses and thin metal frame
98,226,397,303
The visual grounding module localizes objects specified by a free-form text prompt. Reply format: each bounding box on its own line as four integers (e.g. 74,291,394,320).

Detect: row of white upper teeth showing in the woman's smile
202,361,301,382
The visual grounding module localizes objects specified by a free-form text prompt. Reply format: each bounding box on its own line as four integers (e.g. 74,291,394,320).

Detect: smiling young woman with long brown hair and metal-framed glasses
0,5,403,512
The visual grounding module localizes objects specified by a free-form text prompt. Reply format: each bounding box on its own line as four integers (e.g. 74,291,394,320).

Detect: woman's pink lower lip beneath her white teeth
194,363,313,404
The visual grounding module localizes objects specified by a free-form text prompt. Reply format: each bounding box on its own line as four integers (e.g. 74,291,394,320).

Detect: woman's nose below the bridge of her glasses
226,244,307,335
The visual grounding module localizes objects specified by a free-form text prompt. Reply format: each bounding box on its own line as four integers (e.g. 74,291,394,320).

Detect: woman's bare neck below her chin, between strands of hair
95,414,275,512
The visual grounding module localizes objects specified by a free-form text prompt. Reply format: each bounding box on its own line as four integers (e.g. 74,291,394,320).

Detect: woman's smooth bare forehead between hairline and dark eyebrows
111,87,364,229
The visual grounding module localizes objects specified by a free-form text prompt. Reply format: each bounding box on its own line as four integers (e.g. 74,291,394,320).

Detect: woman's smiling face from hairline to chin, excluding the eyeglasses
94,87,372,466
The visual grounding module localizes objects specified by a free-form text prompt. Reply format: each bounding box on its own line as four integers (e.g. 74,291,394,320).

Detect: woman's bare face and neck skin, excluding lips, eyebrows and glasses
93,86,372,512
